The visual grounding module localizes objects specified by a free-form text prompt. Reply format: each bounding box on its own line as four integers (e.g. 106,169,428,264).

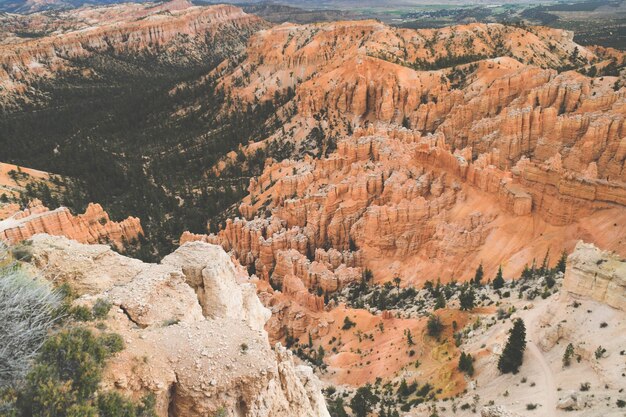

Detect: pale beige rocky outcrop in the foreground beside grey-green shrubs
26,235,329,417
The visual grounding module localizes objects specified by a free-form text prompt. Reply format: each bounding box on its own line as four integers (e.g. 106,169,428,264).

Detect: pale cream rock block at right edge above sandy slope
563,241,626,311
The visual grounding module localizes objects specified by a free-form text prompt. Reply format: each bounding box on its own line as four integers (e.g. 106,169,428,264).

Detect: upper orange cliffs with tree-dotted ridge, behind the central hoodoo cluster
213,21,625,182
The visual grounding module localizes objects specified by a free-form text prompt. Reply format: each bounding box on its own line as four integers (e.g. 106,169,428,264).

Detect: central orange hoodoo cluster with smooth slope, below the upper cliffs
181,122,626,286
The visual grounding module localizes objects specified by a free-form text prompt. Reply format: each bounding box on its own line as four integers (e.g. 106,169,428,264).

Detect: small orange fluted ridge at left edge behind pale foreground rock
0,202,143,249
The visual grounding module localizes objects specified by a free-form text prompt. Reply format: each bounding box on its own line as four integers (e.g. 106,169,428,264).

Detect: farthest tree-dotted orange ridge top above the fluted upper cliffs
216,20,596,106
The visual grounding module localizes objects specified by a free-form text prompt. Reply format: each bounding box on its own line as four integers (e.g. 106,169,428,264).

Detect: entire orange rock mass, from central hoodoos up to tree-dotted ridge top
190,17,626,292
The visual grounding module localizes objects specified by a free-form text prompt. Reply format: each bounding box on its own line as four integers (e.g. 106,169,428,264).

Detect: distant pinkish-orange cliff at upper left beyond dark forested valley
0,0,268,109
